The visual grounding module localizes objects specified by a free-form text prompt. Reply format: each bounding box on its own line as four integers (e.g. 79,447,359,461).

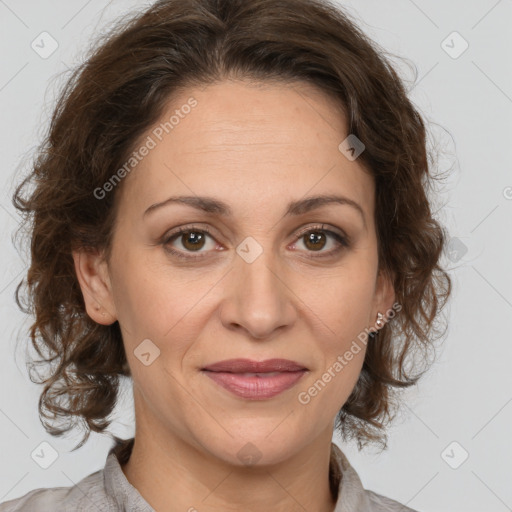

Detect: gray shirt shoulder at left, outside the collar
0,470,115,512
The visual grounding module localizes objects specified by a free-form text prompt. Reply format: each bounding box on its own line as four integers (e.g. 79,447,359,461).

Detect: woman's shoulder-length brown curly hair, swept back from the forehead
13,0,451,449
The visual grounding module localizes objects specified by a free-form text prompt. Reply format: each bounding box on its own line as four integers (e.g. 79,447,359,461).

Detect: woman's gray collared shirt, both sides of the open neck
0,438,416,512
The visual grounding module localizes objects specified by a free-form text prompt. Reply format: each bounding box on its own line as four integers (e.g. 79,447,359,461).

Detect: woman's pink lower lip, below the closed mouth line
203,370,306,400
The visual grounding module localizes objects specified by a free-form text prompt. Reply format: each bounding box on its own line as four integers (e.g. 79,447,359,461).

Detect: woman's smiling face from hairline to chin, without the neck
76,82,394,464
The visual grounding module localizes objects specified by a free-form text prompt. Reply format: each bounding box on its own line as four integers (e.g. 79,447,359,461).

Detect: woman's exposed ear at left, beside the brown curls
72,250,117,325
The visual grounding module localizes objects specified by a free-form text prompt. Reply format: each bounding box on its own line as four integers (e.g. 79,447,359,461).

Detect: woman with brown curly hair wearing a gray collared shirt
0,0,450,512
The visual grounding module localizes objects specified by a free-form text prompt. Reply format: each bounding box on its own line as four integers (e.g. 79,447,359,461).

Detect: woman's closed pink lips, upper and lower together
202,359,307,400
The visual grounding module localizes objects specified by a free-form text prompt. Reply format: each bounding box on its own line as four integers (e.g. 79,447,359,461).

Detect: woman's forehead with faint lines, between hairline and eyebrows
120,81,373,219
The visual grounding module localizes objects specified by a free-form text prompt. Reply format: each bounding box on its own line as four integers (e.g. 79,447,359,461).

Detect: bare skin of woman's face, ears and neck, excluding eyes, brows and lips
73,81,394,512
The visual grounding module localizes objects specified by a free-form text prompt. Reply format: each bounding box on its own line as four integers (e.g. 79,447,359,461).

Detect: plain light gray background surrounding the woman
0,0,512,512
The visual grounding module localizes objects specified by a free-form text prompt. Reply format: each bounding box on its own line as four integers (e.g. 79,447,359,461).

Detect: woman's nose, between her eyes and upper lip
221,247,297,339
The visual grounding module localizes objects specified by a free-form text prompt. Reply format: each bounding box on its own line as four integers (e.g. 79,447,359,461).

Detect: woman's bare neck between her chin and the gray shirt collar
121,426,336,512
